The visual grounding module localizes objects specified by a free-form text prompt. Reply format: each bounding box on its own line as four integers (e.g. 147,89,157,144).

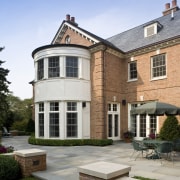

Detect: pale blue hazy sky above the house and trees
0,0,171,99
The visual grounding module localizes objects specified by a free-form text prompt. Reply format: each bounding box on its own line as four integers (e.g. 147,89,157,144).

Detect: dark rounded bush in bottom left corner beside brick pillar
0,155,21,180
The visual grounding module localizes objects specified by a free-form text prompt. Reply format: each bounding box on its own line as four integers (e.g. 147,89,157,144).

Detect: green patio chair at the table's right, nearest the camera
155,142,174,164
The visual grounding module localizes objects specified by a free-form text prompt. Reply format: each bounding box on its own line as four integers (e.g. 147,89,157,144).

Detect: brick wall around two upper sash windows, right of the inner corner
125,45,180,106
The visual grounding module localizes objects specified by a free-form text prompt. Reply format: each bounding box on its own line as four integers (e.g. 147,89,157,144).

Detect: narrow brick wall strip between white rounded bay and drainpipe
91,51,106,139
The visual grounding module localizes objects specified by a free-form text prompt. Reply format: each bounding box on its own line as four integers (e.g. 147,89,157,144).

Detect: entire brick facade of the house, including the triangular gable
33,7,180,139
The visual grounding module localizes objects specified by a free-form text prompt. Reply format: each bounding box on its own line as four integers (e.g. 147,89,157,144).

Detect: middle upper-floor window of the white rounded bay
48,57,60,78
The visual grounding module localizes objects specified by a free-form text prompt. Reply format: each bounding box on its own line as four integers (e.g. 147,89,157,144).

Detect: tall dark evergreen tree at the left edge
0,48,10,127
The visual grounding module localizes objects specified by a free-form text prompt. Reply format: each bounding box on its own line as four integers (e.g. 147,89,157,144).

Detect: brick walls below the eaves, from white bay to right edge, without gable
91,45,180,138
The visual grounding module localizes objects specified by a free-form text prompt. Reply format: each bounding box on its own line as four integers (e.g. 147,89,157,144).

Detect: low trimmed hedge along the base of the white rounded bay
28,136,113,146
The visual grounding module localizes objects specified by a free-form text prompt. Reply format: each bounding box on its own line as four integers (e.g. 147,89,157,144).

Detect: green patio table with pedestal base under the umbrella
142,139,171,159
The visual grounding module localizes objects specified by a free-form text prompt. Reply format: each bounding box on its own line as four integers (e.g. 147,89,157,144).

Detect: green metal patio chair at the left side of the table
131,140,148,160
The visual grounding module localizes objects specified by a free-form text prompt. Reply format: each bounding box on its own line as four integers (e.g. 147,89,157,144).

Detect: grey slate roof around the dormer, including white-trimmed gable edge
51,10,180,53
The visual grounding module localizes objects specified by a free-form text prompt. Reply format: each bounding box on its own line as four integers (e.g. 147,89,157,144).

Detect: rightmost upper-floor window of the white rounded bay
66,56,78,77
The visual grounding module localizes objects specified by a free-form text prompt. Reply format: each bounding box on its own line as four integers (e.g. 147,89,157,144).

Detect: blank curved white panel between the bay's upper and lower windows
35,78,90,102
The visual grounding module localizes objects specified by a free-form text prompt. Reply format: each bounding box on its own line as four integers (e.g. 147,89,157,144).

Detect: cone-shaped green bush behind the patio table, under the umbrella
159,116,180,141
